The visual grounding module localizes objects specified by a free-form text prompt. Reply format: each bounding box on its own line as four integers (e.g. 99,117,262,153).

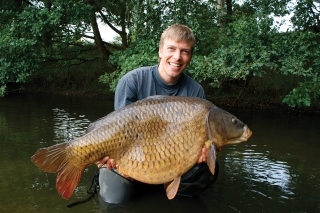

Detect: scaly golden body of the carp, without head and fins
68,97,212,184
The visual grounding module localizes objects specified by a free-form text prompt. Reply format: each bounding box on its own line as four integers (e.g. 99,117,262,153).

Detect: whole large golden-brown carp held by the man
31,96,252,199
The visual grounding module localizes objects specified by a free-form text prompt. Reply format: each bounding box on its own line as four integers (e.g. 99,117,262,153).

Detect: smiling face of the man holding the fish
159,38,193,84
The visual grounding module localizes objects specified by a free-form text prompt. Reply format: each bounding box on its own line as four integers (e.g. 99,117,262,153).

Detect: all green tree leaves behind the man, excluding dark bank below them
0,0,320,107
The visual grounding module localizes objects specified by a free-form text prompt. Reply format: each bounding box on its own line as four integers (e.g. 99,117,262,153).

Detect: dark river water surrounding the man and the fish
0,94,320,213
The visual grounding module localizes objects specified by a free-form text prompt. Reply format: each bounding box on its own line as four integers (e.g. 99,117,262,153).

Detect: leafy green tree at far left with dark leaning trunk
0,0,126,95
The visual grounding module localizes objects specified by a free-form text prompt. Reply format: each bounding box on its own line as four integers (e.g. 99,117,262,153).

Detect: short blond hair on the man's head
159,23,196,52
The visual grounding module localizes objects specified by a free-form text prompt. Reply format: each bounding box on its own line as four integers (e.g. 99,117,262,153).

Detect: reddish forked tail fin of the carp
31,143,85,199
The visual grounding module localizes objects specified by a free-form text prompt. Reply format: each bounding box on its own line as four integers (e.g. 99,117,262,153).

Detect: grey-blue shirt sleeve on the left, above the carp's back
114,76,137,110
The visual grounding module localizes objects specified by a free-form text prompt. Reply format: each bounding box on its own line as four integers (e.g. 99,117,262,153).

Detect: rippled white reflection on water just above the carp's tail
53,108,91,143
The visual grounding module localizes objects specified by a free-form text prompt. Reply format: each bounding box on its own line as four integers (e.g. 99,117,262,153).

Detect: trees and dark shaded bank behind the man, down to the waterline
0,0,320,113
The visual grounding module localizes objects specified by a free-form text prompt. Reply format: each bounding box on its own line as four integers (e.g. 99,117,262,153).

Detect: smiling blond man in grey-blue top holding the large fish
97,24,218,202
